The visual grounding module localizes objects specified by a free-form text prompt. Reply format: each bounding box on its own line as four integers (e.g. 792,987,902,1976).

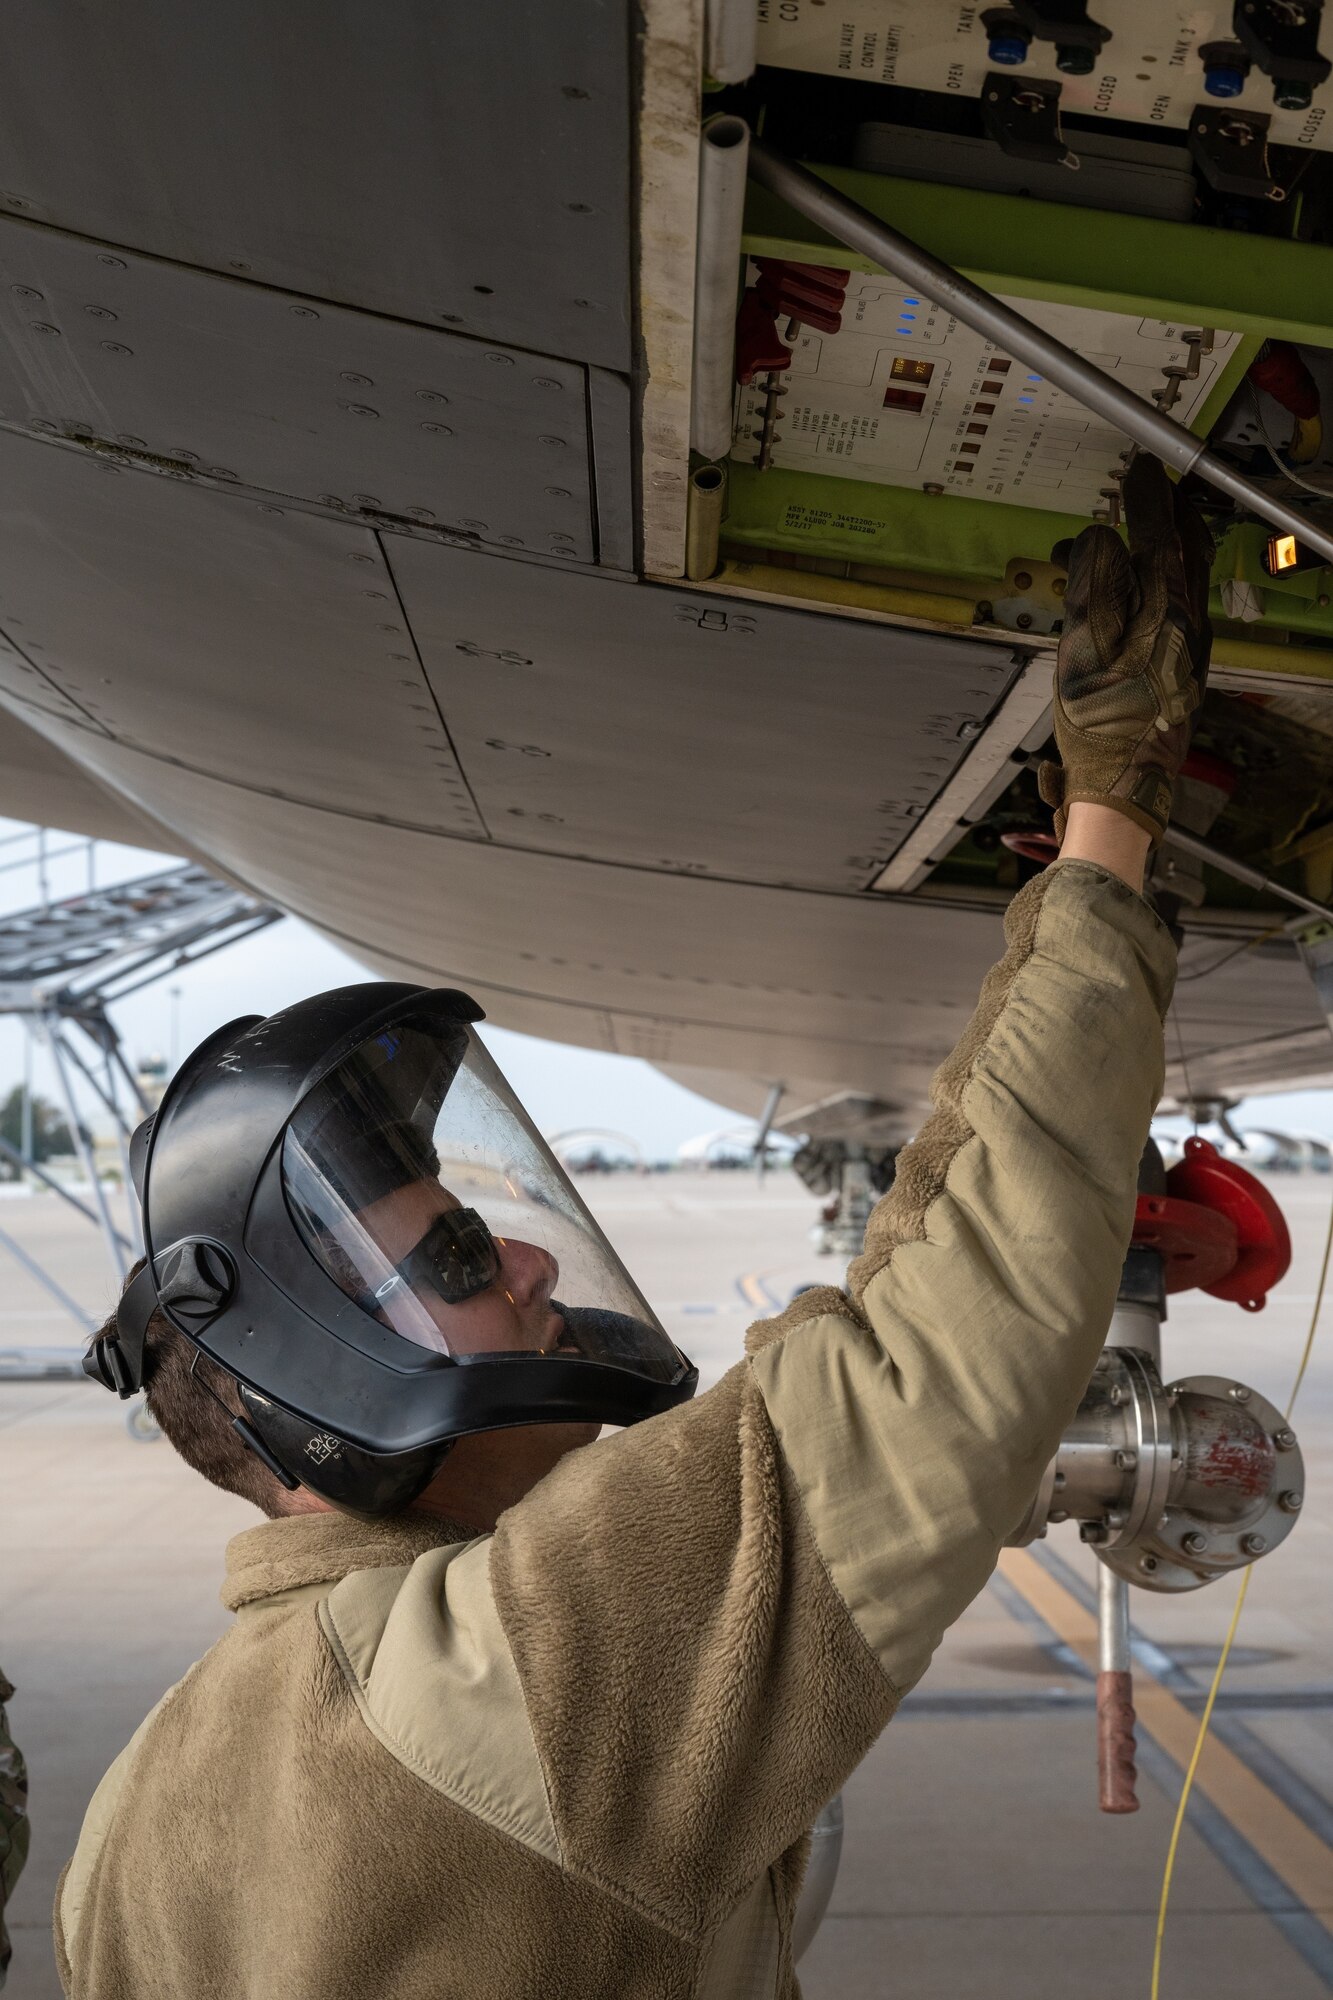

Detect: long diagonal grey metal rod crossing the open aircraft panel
751,138,1333,564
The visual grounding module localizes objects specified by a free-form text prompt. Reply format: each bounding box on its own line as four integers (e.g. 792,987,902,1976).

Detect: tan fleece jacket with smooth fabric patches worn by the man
56,862,1175,2000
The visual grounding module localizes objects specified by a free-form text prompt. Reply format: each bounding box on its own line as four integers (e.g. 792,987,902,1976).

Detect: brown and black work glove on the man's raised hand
1037,452,1213,846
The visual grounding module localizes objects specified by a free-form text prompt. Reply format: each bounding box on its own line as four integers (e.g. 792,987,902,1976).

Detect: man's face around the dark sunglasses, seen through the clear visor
358,1180,566,1354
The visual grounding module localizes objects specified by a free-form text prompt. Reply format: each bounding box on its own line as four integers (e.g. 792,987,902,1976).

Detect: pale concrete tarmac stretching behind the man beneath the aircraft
0,1172,1333,2000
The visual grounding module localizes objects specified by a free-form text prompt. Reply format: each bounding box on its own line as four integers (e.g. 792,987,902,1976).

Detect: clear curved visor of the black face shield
280,1016,691,1386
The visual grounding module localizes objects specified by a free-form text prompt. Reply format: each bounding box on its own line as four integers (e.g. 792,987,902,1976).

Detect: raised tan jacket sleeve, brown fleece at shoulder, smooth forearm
490,862,1175,1930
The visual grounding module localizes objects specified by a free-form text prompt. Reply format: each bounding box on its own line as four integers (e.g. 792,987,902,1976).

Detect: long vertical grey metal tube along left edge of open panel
691,117,753,458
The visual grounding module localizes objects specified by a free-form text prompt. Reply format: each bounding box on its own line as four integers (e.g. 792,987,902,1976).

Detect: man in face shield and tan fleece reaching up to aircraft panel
56,460,1209,2000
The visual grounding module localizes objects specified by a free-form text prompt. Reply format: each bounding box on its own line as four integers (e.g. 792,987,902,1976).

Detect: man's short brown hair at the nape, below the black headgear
94,1258,286,1520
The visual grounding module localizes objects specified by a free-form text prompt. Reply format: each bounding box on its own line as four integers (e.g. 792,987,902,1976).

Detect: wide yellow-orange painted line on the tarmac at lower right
999,1548,1333,1932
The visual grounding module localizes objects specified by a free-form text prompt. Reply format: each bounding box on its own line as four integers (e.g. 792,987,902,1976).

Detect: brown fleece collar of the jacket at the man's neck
222,1514,476,1612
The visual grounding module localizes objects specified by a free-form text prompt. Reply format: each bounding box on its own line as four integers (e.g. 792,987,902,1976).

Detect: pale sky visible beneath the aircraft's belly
0,820,1333,1160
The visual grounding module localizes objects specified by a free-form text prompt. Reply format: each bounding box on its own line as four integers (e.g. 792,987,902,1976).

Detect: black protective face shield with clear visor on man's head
84,984,697,1514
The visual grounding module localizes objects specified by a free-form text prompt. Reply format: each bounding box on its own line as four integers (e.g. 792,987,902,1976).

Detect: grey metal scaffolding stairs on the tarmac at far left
0,828,282,1380
